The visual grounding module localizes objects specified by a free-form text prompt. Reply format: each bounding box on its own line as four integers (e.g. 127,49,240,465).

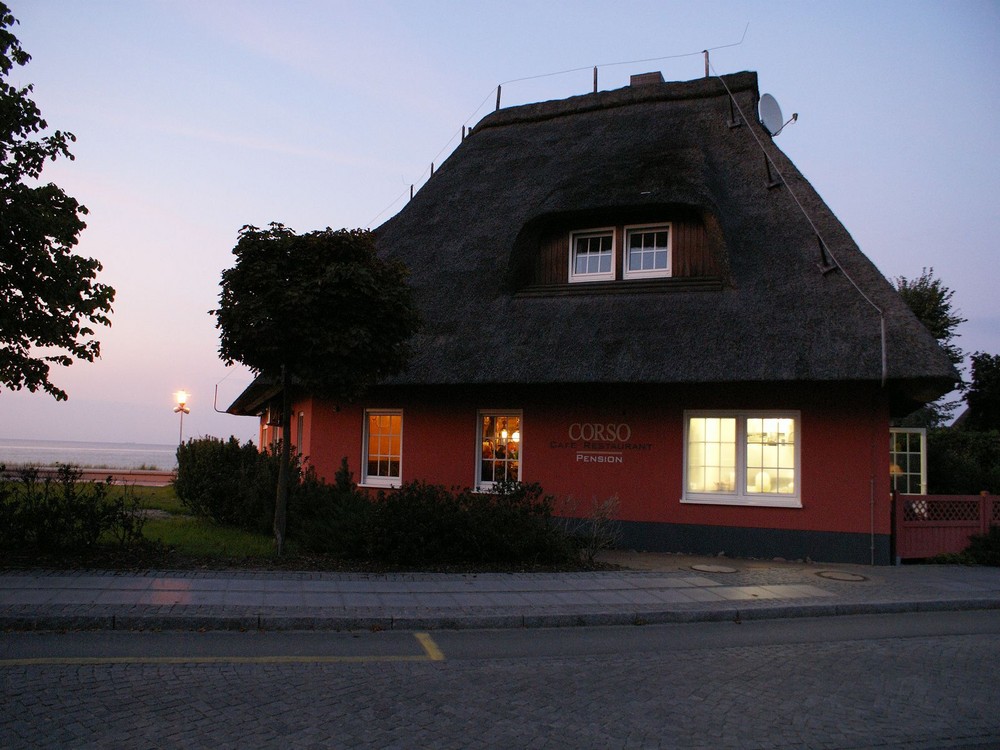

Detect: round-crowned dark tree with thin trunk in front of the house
211,223,419,554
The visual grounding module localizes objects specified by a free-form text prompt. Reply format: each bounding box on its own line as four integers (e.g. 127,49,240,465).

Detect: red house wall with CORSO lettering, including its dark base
295,384,890,562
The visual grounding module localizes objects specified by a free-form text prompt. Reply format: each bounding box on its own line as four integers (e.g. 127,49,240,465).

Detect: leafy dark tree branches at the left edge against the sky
0,2,115,401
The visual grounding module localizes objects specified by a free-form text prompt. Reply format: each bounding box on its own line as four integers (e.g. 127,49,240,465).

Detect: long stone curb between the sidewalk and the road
0,598,1000,632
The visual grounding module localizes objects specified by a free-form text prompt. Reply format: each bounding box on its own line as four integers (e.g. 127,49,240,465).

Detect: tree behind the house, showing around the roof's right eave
896,268,965,427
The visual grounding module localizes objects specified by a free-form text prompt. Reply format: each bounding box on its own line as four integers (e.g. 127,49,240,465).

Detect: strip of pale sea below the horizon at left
0,438,177,471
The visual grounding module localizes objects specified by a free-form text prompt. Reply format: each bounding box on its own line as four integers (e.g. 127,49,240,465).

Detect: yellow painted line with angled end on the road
0,633,444,667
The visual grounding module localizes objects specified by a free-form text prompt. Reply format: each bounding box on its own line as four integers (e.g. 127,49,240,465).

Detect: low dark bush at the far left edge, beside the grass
0,465,146,554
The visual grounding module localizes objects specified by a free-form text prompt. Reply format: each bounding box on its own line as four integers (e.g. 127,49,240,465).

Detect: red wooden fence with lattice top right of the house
893,495,1000,560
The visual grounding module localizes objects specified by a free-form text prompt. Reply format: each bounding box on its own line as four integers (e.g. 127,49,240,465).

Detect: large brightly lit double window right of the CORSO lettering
682,412,802,508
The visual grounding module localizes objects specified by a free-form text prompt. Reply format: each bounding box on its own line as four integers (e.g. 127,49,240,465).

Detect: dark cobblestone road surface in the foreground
0,631,1000,750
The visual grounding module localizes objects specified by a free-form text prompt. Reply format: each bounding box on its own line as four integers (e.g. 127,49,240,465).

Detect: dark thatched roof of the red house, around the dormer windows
376,73,956,418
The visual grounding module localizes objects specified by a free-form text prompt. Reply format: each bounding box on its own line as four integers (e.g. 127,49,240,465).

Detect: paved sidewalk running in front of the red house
0,552,1000,630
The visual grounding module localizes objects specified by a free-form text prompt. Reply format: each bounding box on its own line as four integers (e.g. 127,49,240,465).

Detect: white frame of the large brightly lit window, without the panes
681,410,802,508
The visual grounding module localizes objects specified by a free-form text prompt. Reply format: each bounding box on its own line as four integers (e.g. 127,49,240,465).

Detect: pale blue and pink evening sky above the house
0,0,1000,444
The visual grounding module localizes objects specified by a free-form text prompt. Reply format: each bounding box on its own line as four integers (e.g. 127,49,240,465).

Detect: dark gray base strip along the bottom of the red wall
621,521,892,565
